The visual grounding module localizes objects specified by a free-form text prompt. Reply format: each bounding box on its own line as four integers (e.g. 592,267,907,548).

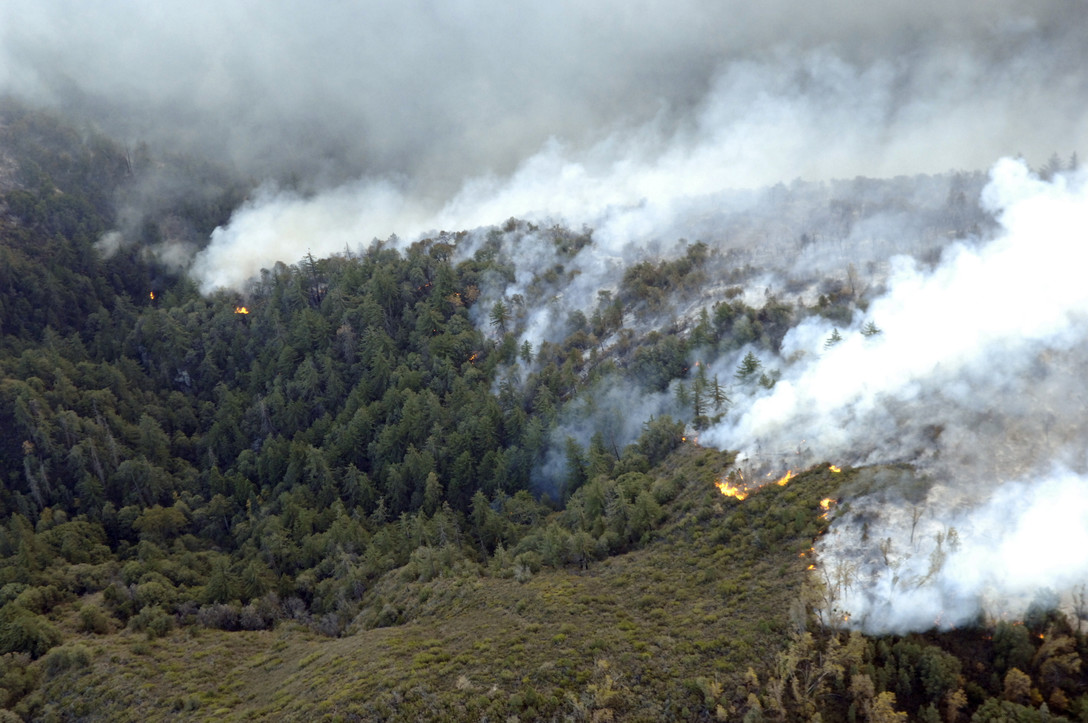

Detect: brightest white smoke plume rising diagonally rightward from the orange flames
704,160,1088,461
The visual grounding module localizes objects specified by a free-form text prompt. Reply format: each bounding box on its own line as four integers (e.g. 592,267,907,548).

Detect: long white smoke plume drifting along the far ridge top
187,38,1079,288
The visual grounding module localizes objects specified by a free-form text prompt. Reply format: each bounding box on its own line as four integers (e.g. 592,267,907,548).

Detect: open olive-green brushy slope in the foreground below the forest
27,447,849,721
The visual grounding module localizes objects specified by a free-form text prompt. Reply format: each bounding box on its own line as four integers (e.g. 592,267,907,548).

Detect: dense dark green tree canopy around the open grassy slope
0,103,1088,721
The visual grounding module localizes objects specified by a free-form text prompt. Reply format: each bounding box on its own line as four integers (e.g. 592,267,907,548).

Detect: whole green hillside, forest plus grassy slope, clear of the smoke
0,100,1088,722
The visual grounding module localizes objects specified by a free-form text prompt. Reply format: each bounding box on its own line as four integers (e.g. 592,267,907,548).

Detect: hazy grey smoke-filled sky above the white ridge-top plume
0,0,1088,200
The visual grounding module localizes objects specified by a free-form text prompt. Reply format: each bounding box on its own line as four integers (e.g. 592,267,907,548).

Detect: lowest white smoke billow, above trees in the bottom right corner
817,468,1088,633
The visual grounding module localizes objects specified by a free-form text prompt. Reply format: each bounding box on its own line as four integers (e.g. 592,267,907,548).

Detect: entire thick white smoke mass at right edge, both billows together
702,160,1088,632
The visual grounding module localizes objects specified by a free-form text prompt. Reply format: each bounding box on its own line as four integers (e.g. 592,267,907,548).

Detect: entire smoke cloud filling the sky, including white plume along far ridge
6,0,1088,290
